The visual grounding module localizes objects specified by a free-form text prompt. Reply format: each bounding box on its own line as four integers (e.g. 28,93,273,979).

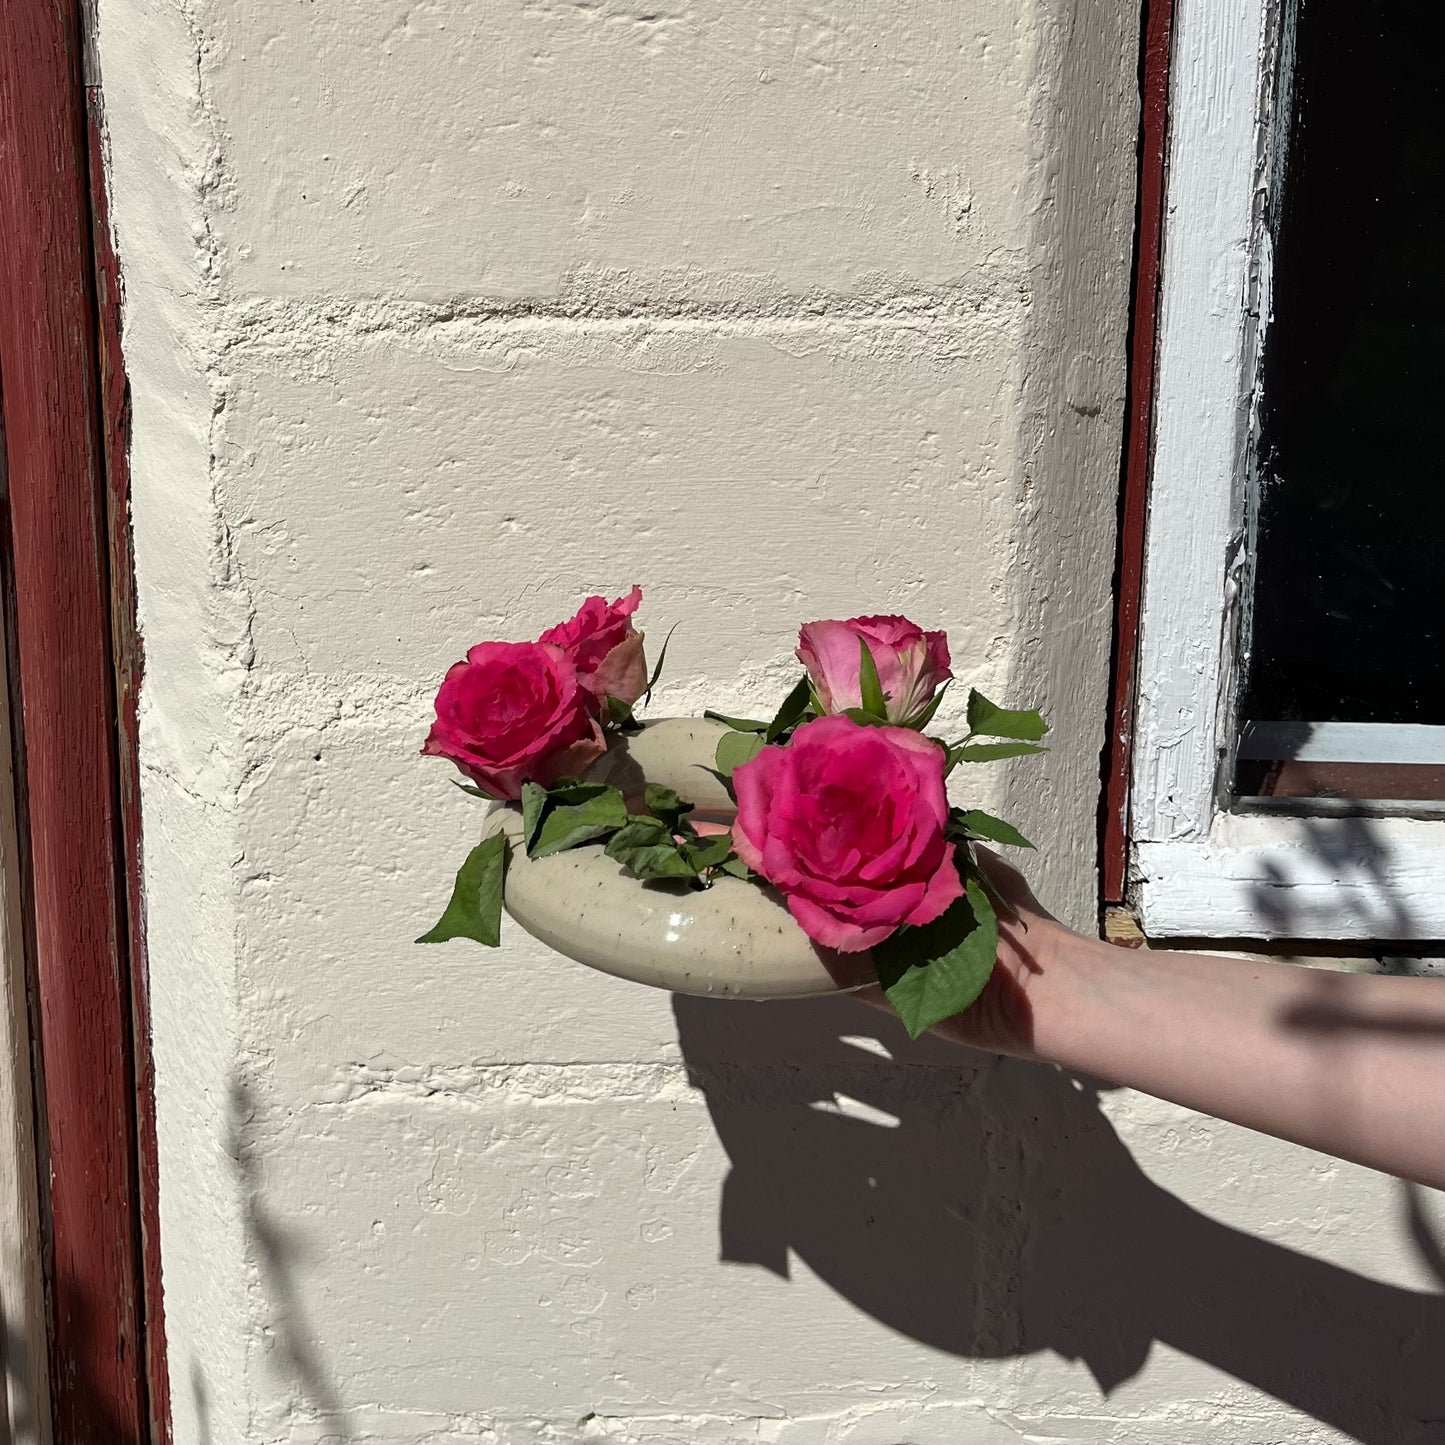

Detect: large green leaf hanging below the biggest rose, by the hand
873,879,998,1039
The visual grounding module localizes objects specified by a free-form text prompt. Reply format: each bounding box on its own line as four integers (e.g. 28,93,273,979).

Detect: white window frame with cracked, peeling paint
1130,0,1445,941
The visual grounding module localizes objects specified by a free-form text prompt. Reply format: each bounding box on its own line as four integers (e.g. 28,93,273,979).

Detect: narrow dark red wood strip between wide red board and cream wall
85,87,171,1445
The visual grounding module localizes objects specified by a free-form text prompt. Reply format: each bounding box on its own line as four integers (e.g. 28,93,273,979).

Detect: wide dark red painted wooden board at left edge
0,0,150,1445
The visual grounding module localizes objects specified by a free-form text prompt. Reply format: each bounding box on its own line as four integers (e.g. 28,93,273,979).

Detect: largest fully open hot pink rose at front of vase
733,718,964,954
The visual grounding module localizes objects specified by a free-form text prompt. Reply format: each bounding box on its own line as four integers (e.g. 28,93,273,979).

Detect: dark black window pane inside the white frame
1241,0,1445,728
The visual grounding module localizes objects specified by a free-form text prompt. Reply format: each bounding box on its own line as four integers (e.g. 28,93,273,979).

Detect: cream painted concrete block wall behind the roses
98,0,1439,1445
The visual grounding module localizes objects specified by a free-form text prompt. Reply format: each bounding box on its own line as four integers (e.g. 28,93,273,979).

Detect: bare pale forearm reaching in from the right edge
1027,929,1445,1186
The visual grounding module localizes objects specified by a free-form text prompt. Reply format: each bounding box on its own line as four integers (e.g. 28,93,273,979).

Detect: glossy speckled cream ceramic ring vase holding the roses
487,718,873,998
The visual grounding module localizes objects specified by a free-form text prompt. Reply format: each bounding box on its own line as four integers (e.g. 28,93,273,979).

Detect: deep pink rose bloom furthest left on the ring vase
422,642,607,801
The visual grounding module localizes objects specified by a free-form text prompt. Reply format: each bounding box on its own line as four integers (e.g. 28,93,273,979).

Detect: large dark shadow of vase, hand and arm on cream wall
675,997,1445,1445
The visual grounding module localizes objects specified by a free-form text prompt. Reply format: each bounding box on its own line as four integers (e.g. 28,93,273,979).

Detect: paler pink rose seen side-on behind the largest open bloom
798,617,954,727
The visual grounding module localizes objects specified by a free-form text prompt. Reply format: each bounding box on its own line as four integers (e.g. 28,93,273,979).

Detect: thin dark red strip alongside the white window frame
1100,0,1173,905
